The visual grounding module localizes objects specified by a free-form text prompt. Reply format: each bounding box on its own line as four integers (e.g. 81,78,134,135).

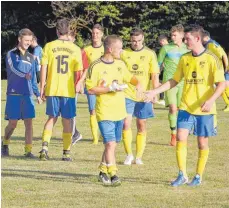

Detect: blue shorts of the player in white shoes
126,98,154,119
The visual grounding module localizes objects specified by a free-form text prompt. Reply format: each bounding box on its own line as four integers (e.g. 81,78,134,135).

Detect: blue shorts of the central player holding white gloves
98,120,124,144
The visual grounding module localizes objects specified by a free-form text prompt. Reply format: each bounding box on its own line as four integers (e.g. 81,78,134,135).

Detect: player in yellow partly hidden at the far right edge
203,30,229,112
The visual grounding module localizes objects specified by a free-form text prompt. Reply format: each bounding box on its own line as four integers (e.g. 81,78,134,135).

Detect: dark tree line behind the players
1,1,229,78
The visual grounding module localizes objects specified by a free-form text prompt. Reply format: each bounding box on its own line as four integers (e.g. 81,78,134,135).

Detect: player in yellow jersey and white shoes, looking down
121,28,159,165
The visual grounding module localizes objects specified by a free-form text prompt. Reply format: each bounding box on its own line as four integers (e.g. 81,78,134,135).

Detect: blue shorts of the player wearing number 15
46,96,76,119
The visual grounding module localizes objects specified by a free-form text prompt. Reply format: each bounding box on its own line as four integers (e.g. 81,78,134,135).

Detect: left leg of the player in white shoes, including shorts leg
122,99,136,165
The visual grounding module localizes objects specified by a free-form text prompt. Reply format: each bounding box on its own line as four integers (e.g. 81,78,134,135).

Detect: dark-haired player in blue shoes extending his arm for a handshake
145,25,225,186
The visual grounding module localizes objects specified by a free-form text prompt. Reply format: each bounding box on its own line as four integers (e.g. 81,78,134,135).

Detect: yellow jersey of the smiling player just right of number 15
84,45,104,65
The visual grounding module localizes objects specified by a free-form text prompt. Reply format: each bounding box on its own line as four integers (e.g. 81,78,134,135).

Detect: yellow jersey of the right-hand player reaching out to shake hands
173,50,225,115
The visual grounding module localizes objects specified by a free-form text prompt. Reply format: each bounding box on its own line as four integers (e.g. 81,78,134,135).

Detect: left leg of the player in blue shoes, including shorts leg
171,110,192,186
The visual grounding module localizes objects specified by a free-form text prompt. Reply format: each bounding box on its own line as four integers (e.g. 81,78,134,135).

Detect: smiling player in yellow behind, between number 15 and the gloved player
77,24,104,144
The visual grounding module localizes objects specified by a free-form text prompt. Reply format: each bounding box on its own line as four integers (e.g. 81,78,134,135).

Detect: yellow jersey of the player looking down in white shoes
121,47,160,102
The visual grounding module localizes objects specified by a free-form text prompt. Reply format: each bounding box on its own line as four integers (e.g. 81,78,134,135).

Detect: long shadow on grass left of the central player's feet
2,168,96,184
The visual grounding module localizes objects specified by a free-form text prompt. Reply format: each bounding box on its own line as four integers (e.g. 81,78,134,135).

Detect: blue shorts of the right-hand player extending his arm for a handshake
177,110,217,137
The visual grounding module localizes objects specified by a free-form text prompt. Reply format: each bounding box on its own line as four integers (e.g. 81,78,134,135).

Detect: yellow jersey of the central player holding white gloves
86,59,133,121
